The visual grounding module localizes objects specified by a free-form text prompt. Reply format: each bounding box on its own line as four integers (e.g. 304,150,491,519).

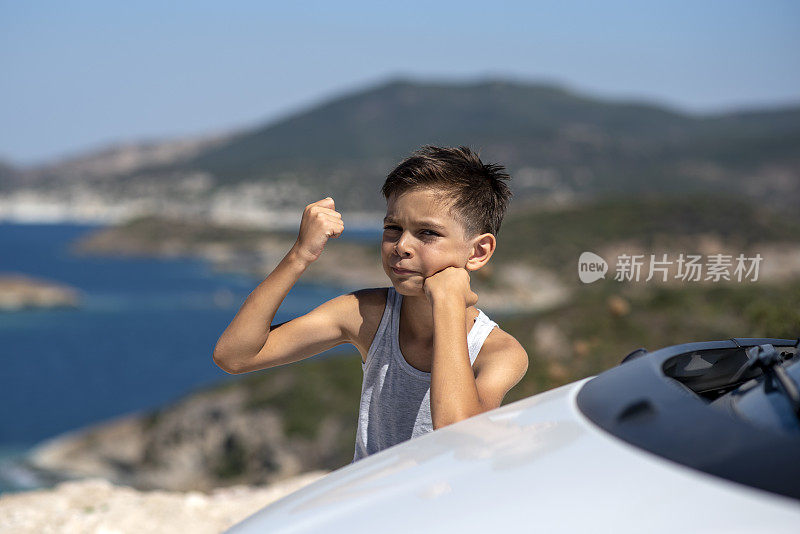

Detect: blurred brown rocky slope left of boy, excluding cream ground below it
14,369,355,492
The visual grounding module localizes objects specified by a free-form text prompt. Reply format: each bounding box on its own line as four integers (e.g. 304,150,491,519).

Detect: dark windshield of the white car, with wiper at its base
577,339,800,500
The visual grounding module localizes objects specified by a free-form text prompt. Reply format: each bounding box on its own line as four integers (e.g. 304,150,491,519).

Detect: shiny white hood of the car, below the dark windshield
227,378,800,534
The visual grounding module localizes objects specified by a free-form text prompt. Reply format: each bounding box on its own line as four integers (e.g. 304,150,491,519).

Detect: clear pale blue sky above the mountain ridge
0,0,800,166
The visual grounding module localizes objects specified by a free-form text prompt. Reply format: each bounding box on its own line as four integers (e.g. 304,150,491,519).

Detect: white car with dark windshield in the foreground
226,338,800,534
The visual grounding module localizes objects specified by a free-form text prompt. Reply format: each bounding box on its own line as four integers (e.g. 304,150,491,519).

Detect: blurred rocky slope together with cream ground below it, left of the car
0,354,360,533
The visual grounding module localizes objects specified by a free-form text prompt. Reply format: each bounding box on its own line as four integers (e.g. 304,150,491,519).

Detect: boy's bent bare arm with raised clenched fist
213,197,351,374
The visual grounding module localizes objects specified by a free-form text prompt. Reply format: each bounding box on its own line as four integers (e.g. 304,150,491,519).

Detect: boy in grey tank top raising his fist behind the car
214,146,528,462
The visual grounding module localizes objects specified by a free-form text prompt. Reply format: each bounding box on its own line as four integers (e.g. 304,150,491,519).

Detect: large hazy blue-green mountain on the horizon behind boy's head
7,79,800,216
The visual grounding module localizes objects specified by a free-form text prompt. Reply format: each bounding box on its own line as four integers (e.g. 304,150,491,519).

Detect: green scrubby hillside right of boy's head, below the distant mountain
492,192,800,277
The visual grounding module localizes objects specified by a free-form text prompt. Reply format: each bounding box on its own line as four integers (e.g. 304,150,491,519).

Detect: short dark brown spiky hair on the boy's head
381,145,512,238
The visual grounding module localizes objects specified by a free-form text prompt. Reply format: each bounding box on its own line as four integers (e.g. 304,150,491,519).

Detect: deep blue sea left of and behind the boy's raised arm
0,222,388,493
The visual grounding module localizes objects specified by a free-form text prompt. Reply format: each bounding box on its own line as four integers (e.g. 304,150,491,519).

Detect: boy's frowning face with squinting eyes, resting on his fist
381,189,472,296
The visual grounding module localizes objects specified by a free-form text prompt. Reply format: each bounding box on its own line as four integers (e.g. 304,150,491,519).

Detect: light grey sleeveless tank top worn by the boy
353,287,497,462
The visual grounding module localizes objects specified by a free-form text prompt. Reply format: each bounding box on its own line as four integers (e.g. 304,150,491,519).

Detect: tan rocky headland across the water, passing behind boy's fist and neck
71,217,570,316
